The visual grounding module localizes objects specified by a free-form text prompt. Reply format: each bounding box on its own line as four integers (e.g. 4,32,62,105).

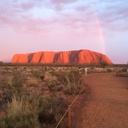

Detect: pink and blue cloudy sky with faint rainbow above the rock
0,0,128,64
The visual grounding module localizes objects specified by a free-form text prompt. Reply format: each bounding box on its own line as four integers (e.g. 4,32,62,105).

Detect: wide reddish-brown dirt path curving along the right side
72,73,128,128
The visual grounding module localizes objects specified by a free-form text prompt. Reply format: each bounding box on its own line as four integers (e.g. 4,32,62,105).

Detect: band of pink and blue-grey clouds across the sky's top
0,0,128,32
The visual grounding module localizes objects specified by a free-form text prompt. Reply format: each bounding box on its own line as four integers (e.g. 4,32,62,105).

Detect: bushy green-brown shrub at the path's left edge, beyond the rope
51,70,83,94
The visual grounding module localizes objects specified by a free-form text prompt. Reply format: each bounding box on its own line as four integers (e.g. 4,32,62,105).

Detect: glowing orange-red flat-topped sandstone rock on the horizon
11,50,112,64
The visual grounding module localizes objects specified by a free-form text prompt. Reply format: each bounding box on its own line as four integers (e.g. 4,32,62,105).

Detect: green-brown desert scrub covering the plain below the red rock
0,64,128,128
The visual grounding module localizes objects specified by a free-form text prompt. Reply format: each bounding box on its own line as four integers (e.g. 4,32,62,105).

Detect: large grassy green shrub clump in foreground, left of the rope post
0,94,67,128
